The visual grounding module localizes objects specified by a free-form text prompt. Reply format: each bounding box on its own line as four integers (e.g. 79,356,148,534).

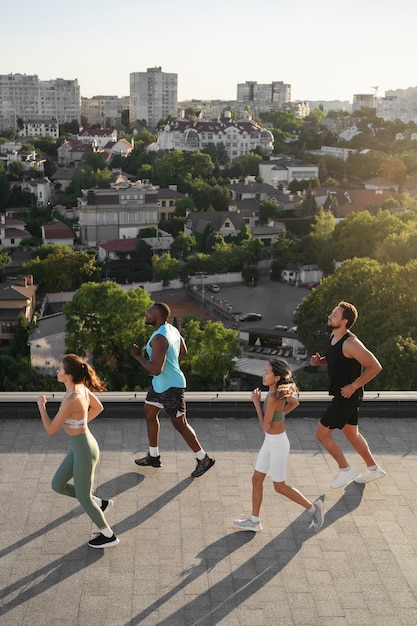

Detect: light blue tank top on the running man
146,323,187,393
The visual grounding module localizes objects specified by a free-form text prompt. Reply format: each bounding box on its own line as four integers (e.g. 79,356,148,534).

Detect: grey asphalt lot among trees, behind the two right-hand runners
210,277,311,328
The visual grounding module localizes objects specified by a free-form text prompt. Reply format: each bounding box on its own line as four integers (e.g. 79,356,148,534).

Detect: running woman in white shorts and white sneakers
233,359,324,532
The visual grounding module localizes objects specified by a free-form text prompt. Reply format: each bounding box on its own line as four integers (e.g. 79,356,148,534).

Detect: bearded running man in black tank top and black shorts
310,302,385,489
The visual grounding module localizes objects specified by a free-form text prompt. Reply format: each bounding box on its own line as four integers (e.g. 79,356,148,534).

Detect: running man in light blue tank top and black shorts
130,302,214,478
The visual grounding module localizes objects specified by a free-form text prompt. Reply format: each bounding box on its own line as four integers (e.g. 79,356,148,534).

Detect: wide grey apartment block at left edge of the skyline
0,74,81,129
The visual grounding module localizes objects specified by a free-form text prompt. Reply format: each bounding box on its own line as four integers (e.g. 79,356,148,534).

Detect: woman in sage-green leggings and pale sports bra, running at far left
38,354,119,548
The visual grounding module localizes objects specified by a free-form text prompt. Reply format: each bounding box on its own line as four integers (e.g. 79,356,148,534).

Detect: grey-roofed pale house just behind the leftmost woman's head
28,313,66,376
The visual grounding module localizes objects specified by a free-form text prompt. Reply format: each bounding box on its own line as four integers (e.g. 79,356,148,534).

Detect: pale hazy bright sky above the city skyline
4,0,417,102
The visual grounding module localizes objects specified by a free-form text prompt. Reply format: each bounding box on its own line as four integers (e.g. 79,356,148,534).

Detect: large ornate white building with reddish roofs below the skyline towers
157,112,274,161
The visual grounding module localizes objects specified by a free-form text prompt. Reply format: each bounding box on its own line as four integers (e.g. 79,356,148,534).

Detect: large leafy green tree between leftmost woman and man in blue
63,282,151,391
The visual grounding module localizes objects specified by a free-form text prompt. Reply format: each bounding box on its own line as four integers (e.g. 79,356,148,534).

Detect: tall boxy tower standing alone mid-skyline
130,67,178,127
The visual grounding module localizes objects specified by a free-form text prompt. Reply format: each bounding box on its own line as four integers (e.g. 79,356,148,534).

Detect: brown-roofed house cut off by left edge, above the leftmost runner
0,276,37,345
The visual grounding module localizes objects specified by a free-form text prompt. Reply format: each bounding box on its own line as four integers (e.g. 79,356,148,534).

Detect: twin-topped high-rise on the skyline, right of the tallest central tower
237,81,291,112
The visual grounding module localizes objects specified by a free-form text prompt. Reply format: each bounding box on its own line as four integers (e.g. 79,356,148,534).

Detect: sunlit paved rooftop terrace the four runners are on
0,416,417,626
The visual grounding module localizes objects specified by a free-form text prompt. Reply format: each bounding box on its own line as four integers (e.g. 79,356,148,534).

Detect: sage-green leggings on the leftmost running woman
52,430,107,528
